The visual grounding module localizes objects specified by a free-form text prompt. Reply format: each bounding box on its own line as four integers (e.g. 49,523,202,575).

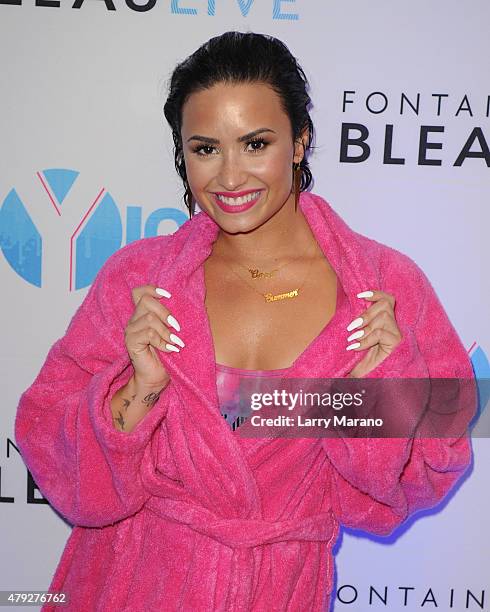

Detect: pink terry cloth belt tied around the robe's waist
145,497,338,548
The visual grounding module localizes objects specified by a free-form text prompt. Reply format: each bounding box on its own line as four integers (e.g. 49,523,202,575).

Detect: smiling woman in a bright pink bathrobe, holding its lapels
16,32,474,611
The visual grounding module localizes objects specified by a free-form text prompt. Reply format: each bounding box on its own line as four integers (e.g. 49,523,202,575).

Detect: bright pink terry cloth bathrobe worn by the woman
15,192,476,612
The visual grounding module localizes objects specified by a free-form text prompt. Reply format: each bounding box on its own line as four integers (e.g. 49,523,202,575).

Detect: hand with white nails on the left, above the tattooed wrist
124,285,185,387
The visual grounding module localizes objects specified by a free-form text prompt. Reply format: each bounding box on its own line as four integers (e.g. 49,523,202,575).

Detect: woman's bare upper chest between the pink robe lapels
204,257,337,370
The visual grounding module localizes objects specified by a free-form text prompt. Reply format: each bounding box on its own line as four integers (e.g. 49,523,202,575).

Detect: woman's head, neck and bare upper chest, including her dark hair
165,63,337,370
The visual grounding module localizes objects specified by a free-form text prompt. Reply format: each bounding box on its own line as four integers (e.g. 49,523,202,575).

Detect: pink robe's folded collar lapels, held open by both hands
151,192,380,466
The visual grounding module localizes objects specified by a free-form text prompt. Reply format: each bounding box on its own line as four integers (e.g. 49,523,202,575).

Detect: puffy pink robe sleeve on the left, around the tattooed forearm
15,245,172,527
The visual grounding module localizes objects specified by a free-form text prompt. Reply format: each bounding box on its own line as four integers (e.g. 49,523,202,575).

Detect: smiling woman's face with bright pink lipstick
181,83,306,233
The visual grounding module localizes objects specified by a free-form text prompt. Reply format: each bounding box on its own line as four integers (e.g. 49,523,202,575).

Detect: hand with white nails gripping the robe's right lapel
347,290,402,378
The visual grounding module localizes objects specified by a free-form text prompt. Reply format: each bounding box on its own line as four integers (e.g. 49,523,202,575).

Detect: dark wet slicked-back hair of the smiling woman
164,31,314,215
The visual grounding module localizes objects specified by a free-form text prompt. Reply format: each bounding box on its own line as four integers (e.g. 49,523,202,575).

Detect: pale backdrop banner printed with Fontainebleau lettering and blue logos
0,0,490,612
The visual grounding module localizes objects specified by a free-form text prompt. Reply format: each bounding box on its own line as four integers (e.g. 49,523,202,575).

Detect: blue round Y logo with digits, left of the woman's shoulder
0,168,188,291
